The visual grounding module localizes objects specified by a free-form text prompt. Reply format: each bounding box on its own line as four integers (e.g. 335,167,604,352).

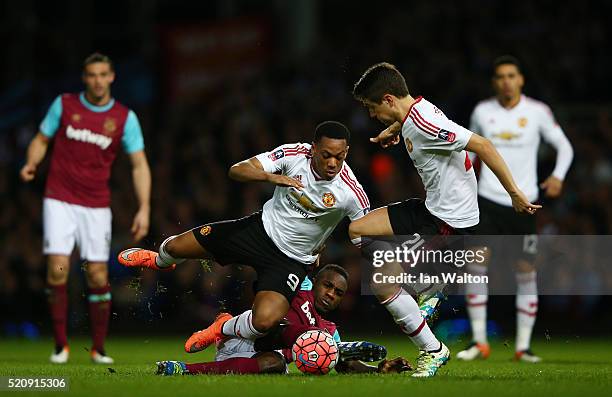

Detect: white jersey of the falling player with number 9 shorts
256,143,370,264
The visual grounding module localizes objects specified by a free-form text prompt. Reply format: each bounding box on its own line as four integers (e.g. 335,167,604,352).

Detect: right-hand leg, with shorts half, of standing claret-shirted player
76,207,114,364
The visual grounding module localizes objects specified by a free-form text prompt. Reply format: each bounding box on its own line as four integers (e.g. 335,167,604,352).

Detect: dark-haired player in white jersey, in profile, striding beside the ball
349,62,541,377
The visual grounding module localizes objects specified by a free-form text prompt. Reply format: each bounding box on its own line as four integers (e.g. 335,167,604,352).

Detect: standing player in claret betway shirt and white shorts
20,53,151,364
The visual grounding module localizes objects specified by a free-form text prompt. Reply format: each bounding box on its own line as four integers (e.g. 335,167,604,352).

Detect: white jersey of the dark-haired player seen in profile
402,97,479,228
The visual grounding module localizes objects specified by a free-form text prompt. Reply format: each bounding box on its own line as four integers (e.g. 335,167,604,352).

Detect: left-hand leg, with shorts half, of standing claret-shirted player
43,198,76,364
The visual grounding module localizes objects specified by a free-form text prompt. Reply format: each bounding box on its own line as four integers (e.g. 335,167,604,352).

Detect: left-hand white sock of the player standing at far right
465,264,489,343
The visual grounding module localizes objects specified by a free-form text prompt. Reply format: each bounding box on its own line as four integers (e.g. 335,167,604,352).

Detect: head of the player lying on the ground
312,264,348,313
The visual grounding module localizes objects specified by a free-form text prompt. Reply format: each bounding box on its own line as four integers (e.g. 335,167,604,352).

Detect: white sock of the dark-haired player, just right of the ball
381,288,441,351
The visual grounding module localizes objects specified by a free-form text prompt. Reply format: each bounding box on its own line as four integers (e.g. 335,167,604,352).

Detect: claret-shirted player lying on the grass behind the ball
157,265,411,375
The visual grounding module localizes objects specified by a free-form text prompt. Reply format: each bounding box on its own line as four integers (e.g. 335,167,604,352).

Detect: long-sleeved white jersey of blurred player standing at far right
470,95,573,207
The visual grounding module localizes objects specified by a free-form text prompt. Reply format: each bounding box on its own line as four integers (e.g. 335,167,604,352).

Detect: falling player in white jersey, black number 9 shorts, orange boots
119,121,370,352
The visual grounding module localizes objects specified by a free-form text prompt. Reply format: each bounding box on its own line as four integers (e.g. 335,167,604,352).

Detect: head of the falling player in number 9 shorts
312,121,351,180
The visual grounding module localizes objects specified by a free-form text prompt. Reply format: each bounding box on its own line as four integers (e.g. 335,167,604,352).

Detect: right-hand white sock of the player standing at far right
516,271,538,352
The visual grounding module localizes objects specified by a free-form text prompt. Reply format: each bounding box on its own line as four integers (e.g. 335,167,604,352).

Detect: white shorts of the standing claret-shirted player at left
43,198,112,262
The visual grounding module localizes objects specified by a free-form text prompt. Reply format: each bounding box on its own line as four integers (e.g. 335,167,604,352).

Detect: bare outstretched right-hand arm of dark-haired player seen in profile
465,134,542,214
